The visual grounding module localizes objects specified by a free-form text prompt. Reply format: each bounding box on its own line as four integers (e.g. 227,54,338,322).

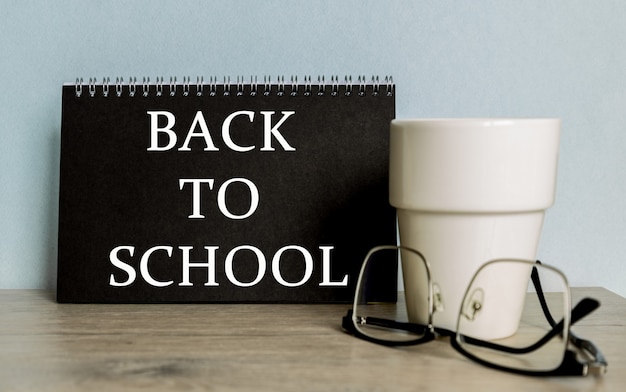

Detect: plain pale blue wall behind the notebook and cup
0,0,626,296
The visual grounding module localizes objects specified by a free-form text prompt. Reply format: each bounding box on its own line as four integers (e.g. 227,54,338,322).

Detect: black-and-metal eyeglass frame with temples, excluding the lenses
342,245,608,376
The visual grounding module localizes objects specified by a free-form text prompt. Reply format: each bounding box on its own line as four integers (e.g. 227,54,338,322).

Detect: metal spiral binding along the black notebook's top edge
74,75,395,97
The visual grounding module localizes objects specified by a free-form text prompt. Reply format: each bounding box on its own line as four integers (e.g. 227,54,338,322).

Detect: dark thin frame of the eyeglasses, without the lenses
342,245,607,376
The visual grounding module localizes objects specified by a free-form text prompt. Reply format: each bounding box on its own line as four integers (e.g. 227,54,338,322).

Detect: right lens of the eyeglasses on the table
456,260,570,372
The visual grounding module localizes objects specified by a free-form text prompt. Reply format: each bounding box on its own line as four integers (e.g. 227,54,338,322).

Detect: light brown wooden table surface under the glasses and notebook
0,288,626,392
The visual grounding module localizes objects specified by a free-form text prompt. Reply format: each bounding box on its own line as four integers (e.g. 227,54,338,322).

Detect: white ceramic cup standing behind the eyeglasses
389,118,560,337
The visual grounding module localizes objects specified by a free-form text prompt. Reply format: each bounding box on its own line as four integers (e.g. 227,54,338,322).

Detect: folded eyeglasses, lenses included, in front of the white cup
343,246,607,376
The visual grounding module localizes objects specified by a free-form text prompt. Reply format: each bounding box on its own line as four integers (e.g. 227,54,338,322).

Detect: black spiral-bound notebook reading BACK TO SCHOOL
57,78,397,303
